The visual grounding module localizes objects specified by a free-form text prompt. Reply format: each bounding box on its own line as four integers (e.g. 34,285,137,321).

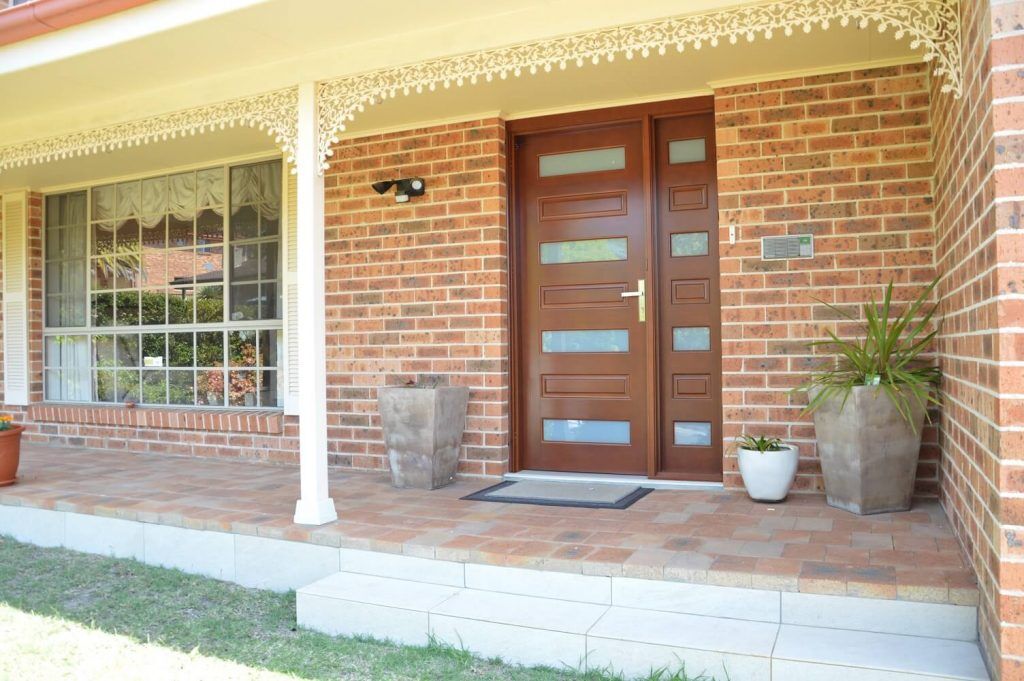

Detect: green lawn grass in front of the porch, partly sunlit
0,538,711,681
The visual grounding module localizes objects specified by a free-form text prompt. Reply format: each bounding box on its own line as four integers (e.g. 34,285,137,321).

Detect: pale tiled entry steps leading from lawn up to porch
297,569,989,681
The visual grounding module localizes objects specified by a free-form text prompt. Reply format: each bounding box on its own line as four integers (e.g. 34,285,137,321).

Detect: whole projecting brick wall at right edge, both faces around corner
933,1,1024,681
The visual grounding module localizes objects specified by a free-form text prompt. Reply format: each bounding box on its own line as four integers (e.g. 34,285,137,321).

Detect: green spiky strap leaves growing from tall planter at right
797,280,942,430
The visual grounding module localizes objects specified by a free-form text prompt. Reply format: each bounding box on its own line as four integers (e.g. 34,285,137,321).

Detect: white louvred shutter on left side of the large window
0,190,31,406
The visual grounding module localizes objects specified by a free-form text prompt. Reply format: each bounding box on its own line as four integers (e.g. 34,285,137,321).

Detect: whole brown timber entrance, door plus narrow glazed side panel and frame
509,98,722,480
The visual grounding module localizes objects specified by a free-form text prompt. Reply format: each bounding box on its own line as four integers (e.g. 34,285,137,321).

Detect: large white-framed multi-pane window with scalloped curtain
44,161,283,408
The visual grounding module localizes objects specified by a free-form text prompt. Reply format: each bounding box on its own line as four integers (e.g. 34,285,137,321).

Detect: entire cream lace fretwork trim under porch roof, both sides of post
0,0,963,171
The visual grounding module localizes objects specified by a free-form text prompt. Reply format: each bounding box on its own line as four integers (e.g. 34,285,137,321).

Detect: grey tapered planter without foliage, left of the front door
377,386,469,490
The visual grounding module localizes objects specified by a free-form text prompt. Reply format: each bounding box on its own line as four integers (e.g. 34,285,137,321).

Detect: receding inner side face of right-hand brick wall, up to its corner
933,2,999,667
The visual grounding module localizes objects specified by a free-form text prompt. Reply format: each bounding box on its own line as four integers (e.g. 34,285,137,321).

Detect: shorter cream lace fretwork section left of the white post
0,88,299,171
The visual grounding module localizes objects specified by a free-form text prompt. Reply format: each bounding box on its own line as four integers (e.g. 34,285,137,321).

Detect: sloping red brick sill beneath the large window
28,403,285,435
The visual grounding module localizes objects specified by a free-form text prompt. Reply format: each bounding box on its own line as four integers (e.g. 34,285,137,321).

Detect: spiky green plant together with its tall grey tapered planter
798,282,941,514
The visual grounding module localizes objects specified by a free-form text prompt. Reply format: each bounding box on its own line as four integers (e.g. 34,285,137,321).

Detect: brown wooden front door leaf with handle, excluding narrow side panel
517,122,648,473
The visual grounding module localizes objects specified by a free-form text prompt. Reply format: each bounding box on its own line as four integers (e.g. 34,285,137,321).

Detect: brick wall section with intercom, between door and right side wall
715,65,938,494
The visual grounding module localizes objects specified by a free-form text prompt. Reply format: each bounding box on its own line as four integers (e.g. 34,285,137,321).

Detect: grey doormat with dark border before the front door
463,480,653,509
